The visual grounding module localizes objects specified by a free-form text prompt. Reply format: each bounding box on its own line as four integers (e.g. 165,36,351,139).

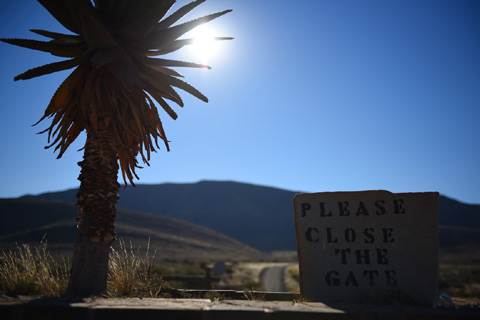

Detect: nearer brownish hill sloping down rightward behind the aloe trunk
0,199,266,261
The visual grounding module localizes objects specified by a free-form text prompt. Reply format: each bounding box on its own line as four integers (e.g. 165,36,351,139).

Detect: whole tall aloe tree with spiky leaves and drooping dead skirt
1,0,231,296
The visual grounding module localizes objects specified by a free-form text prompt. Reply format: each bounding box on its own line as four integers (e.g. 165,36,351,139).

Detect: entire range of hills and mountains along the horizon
0,181,480,264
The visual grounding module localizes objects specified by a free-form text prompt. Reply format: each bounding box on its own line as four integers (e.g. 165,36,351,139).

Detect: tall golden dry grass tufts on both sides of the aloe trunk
0,240,172,298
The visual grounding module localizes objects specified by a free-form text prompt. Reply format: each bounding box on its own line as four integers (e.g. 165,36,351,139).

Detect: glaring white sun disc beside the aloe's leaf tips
191,25,219,64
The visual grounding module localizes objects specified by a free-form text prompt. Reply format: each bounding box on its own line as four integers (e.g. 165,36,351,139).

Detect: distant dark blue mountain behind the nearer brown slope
20,181,480,251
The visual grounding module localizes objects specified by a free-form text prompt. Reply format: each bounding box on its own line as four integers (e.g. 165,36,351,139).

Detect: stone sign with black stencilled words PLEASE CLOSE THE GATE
293,190,439,304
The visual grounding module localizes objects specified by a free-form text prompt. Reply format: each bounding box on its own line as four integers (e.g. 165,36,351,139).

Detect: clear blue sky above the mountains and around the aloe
0,0,480,203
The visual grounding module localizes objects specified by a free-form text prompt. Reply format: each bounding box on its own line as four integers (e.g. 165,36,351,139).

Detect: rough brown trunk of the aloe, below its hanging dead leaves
67,130,120,297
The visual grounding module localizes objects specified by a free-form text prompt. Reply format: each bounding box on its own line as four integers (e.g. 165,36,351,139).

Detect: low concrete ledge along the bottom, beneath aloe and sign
0,298,480,320
